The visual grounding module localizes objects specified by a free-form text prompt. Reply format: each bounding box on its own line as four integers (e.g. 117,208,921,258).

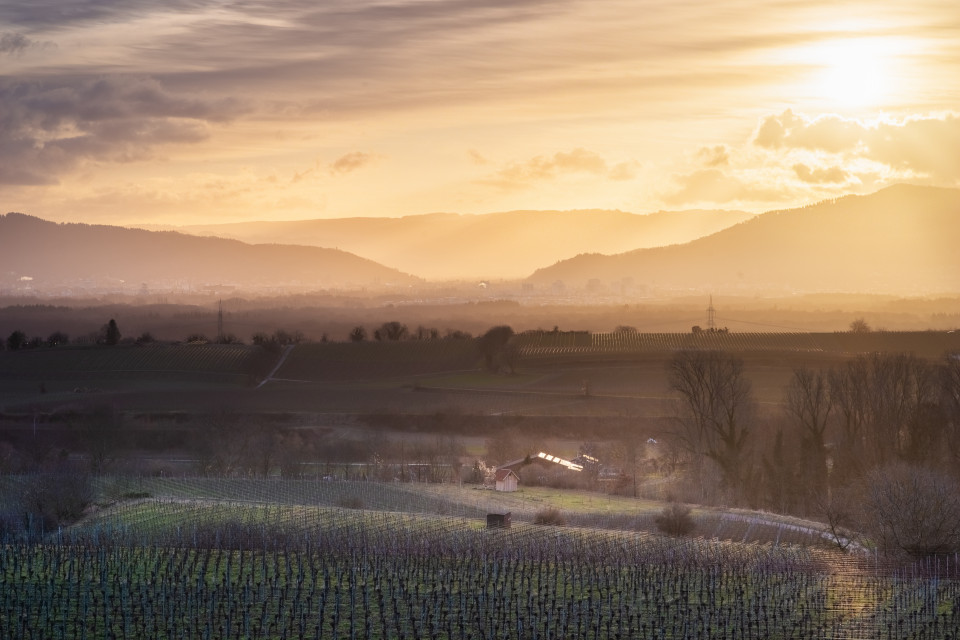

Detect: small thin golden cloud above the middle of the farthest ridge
481,148,637,189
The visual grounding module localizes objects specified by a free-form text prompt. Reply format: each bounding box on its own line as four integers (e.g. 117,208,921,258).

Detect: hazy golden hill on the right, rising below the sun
530,185,960,295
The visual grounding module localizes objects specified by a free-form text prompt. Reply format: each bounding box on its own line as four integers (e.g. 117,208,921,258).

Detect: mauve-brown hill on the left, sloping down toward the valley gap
0,213,417,289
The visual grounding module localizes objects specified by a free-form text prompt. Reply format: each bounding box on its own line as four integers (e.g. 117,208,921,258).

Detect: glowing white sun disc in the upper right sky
811,39,891,111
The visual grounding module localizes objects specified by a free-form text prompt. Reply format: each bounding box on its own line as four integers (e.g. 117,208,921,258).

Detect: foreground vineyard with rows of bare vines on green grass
0,490,960,639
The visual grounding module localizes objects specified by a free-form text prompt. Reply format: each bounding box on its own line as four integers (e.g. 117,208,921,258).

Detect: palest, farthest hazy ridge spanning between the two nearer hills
179,210,752,280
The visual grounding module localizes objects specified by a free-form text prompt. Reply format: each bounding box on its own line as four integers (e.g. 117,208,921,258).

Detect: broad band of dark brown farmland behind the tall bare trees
0,332,960,417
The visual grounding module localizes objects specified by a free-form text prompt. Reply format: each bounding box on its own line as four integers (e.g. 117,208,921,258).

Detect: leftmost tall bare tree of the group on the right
667,351,753,495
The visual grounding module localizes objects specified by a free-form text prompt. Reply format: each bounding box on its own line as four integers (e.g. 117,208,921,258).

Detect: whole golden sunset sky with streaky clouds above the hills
0,0,960,225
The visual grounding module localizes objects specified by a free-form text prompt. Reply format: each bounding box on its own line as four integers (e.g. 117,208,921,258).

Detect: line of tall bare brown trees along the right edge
667,351,960,554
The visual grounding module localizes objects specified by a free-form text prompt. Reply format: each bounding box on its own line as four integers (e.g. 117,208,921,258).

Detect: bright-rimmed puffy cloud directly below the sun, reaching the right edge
753,110,960,182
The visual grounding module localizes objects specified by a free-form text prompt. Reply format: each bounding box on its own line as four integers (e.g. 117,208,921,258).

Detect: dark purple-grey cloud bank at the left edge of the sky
0,76,248,185
